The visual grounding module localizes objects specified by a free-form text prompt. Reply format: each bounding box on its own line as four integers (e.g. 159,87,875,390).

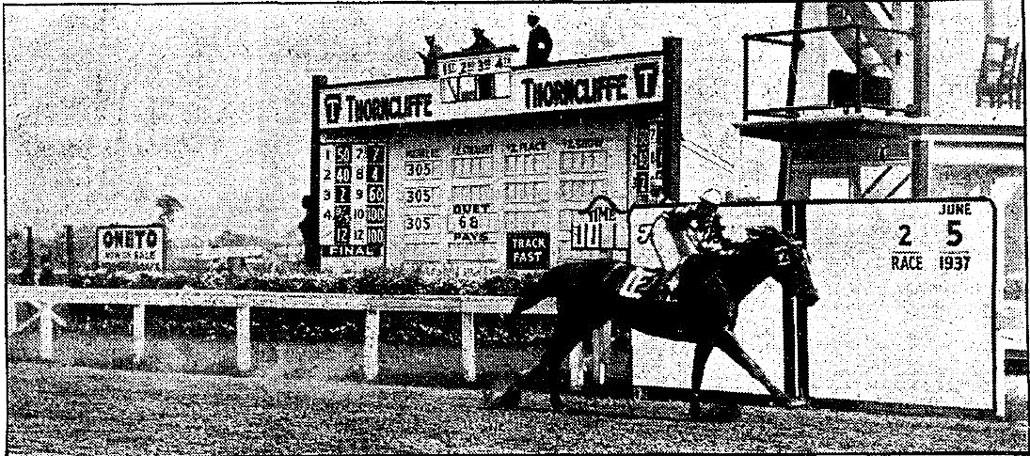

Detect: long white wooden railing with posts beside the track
7,286,604,386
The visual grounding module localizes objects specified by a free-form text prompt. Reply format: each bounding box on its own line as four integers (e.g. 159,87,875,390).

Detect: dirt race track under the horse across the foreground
6,362,1027,454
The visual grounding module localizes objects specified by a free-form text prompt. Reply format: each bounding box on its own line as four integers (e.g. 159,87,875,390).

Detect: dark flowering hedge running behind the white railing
14,267,553,347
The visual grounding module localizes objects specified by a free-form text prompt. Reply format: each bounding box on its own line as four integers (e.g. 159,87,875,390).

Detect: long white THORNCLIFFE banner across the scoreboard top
318,52,663,128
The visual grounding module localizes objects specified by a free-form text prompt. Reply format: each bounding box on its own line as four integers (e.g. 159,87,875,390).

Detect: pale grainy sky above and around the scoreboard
3,3,793,239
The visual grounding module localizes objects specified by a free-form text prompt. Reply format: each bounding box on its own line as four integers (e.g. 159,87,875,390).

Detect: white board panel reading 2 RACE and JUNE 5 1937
806,199,997,409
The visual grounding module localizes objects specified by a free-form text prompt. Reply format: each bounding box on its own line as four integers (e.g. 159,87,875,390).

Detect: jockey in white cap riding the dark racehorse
655,188,728,300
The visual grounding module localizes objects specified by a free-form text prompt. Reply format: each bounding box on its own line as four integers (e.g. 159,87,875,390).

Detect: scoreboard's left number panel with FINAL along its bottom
319,143,386,256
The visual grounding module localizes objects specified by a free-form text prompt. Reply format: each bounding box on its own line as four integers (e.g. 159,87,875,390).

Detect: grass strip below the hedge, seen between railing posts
7,330,629,394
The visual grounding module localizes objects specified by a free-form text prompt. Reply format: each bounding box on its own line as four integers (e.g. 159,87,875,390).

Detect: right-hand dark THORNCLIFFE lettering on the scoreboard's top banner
522,74,629,108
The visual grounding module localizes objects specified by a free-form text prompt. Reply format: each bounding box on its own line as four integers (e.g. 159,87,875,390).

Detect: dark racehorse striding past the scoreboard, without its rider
484,226,819,418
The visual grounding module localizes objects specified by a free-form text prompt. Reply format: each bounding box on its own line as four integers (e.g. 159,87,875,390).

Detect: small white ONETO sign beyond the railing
97,224,165,270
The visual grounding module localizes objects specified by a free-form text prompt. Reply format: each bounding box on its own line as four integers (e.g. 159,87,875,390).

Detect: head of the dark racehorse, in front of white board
747,226,819,306
